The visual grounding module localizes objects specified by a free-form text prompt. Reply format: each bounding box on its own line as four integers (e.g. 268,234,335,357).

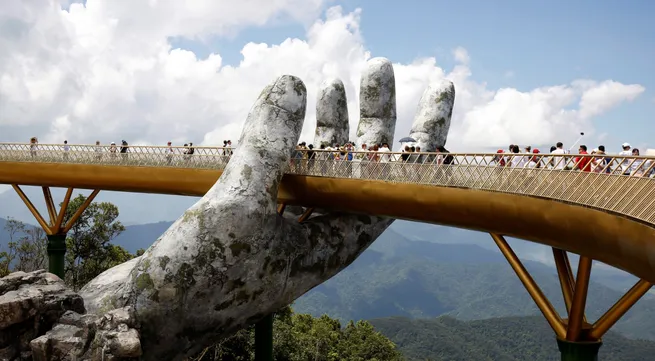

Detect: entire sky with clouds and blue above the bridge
0,0,655,193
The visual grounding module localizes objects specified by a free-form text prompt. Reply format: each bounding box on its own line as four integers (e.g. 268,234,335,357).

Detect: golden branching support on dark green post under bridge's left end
12,184,100,280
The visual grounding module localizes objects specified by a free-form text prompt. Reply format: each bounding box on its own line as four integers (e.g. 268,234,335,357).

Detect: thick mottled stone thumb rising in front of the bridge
206,75,307,208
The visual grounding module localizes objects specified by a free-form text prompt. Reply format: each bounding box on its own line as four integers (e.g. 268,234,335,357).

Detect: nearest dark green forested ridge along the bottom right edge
370,317,655,361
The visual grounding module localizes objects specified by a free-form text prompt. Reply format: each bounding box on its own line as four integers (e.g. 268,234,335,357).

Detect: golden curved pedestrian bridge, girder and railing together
0,145,655,282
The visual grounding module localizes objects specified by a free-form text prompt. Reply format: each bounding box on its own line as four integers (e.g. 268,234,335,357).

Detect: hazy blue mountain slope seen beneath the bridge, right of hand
293,231,655,339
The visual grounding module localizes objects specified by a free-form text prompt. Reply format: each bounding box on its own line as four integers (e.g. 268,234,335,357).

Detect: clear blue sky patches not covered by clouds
174,0,655,150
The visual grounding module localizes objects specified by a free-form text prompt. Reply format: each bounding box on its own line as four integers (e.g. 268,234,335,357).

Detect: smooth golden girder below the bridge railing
0,162,655,282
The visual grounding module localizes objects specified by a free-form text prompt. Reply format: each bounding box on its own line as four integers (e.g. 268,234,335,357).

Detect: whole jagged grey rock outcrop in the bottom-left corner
0,270,141,361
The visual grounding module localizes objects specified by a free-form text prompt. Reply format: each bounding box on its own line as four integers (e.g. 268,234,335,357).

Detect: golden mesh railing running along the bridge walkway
0,143,655,225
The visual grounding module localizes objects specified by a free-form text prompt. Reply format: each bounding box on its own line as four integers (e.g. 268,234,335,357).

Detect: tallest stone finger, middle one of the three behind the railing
357,58,396,149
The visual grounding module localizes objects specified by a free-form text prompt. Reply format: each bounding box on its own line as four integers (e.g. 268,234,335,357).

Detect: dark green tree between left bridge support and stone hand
64,194,134,290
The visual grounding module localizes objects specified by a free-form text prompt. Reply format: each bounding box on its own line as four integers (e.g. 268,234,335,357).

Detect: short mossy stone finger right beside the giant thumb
314,78,350,147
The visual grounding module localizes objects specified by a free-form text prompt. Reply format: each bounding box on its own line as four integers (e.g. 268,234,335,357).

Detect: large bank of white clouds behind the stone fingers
0,0,644,150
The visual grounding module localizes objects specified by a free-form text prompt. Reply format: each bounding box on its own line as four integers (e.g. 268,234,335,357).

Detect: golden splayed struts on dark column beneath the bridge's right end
491,233,653,361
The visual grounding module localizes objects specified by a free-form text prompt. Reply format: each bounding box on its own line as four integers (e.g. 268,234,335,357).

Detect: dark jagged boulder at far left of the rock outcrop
0,270,85,360
